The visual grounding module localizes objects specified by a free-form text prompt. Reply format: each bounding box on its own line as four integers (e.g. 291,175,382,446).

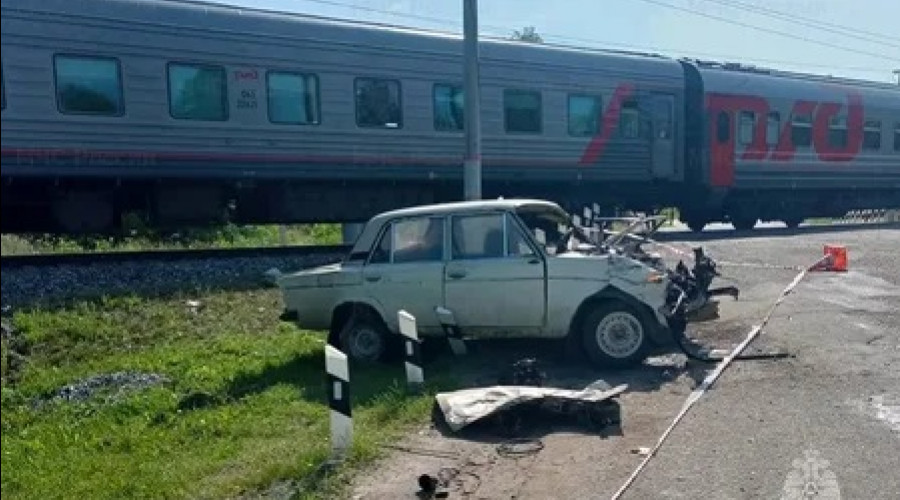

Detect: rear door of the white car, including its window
363,217,446,333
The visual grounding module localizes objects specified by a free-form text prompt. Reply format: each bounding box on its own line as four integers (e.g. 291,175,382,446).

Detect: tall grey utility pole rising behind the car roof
463,0,481,200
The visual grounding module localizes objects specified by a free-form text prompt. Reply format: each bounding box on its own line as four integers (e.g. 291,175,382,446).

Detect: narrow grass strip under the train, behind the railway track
2,224,341,255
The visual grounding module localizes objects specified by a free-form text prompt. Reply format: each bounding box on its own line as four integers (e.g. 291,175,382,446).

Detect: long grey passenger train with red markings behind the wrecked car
0,0,900,234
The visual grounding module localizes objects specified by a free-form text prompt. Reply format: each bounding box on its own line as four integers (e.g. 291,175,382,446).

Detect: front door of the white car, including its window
444,212,546,336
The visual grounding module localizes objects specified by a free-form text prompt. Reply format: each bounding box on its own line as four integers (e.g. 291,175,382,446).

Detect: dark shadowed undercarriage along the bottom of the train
0,177,900,235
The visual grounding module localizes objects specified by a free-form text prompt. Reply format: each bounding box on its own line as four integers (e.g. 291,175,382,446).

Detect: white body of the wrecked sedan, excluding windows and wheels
279,200,680,344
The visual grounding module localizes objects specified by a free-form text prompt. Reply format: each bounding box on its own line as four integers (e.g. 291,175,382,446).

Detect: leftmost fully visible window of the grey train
53,55,124,116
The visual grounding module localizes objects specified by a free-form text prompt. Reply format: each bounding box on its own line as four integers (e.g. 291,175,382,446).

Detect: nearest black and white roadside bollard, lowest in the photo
325,345,353,460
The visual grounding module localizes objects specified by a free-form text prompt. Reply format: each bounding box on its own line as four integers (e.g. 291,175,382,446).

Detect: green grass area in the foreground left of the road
2,290,451,499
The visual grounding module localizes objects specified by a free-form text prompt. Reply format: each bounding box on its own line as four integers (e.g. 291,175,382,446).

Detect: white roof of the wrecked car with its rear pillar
352,198,564,253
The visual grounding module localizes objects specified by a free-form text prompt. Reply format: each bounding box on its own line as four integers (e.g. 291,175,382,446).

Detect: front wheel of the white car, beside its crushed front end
581,301,650,369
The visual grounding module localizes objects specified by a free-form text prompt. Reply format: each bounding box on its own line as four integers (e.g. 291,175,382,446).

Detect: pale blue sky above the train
212,0,900,82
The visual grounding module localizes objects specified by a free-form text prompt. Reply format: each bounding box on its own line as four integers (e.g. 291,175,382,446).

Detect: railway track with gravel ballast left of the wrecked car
0,245,349,311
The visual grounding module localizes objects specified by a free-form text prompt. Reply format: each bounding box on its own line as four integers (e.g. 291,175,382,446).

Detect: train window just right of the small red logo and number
266,71,321,125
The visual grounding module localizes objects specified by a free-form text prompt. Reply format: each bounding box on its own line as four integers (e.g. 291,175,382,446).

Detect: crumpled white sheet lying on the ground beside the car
435,385,628,432
